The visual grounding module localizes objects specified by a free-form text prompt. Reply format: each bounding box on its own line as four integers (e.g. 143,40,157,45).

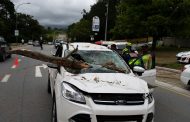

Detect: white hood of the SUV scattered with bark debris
64,73,148,93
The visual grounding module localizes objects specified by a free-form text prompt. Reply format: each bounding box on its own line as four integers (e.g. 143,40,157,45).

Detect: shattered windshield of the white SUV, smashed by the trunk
66,50,130,74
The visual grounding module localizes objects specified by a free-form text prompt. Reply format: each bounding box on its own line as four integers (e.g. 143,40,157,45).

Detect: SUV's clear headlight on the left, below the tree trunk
62,82,86,104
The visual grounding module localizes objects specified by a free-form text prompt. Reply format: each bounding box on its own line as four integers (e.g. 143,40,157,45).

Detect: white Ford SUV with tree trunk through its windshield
48,43,154,122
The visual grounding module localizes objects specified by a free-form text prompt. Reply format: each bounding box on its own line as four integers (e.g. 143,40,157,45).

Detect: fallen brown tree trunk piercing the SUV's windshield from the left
9,49,89,69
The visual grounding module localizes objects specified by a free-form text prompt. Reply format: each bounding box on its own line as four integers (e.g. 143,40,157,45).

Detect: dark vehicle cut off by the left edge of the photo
0,36,11,61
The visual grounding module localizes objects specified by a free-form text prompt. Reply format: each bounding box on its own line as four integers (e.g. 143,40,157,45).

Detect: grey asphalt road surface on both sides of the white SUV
0,45,190,122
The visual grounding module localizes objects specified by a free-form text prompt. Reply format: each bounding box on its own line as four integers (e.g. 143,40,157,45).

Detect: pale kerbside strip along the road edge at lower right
156,80,190,98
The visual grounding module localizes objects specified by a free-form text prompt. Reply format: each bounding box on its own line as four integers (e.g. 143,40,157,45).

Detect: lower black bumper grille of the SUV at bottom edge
96,115,143,122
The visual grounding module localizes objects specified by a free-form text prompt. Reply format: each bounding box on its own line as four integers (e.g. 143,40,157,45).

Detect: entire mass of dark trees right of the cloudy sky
68,0,190,40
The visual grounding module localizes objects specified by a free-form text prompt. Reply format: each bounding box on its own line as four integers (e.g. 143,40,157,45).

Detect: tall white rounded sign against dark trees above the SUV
92,16,100,32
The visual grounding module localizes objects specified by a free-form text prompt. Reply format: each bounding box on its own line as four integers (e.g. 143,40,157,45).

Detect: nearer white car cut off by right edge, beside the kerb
180,64,190,85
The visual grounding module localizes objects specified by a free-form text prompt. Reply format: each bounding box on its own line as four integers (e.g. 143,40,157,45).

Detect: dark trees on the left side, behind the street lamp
0,0,45,43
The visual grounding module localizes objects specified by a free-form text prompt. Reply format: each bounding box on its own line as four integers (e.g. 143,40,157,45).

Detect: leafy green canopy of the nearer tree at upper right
112,0,190,38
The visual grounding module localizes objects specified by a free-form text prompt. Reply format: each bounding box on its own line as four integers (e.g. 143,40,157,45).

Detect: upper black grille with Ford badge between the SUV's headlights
90,94,144,105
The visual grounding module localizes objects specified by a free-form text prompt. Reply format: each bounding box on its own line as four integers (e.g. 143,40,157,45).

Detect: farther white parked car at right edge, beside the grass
176,51,190,64
